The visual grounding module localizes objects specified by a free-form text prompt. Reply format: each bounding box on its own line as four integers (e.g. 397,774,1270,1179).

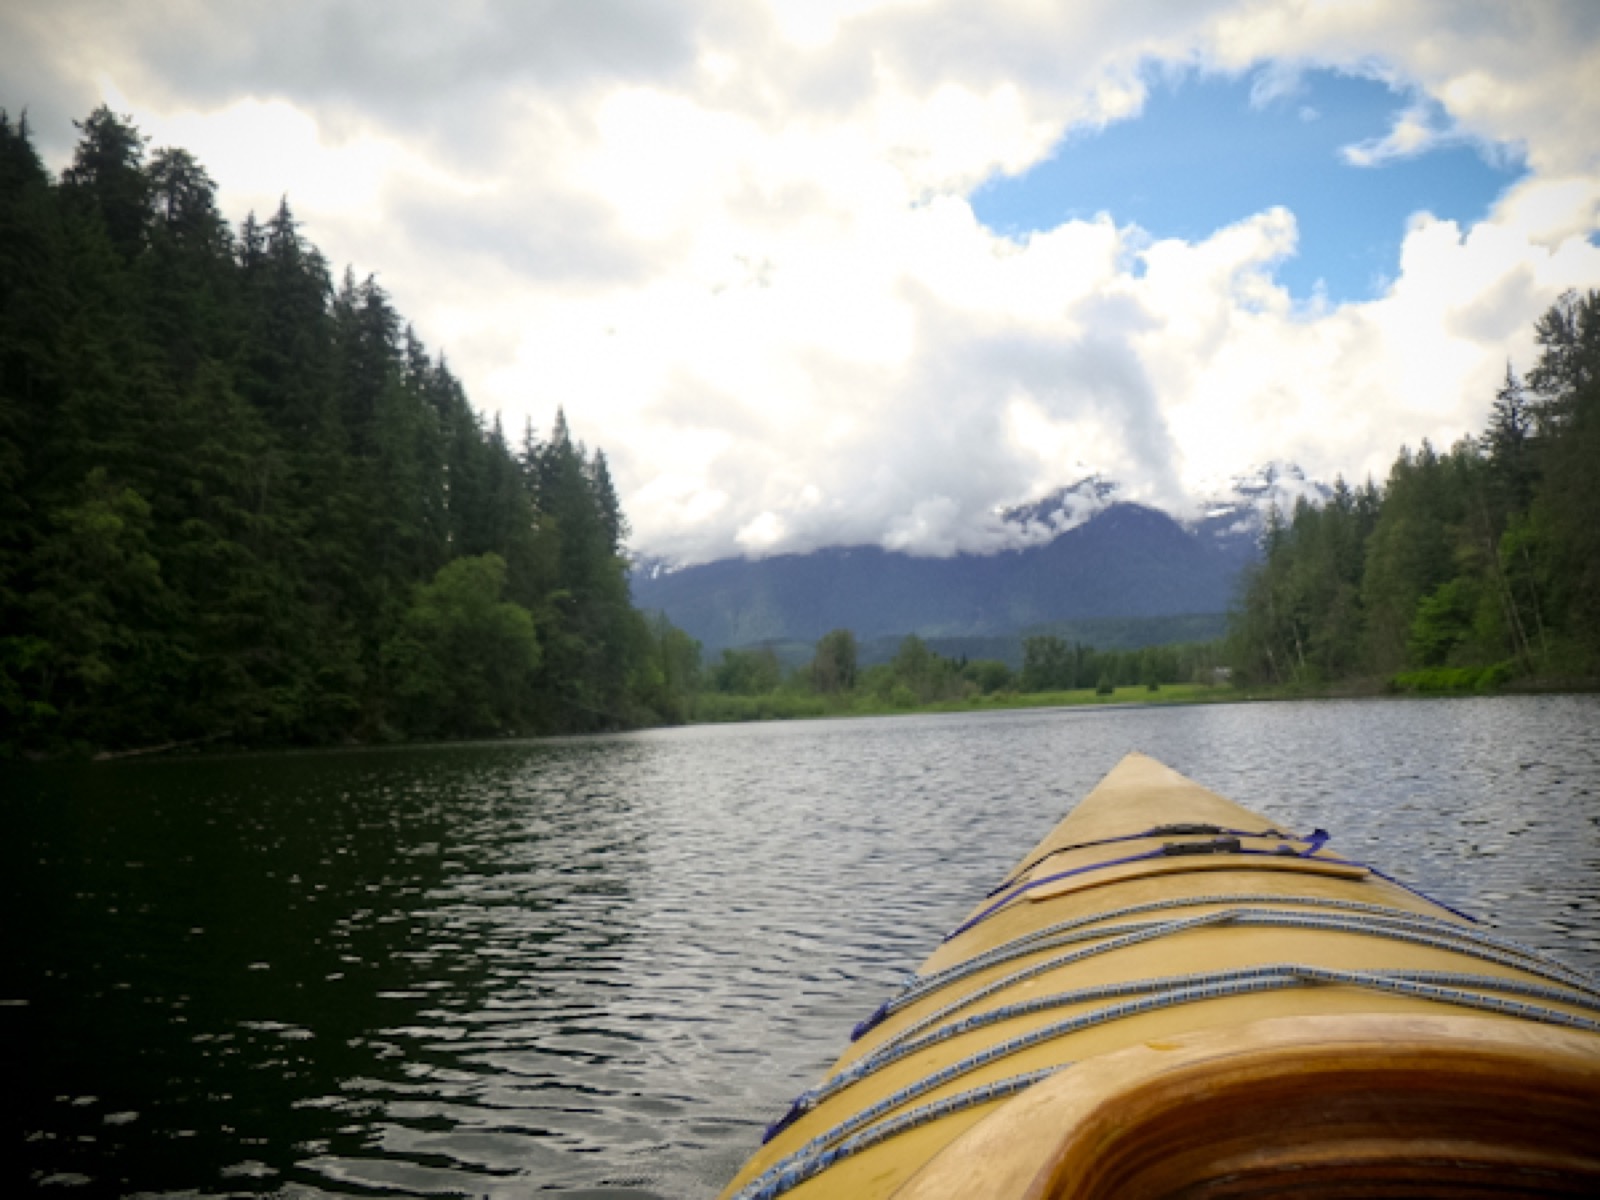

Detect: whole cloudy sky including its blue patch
0,0,1600,563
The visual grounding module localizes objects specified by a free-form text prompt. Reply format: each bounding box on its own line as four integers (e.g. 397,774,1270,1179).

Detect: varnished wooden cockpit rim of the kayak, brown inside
902,1016,1600,1200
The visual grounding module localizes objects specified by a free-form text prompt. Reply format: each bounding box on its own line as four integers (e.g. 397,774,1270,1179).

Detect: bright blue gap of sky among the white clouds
971,70,1525,302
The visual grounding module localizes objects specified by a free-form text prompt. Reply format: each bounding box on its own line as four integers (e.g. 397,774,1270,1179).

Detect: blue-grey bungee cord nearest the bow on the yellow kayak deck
870,893,1600,1042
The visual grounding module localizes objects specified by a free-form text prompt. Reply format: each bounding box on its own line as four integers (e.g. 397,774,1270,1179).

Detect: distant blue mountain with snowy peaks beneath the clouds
634,466,1317,651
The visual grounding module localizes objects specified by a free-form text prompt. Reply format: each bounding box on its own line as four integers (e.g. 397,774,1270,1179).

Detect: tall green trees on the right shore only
1227,291,1600,690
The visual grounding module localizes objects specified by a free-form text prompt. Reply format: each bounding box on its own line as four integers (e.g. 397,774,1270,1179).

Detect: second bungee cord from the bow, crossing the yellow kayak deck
869,909,1600,1058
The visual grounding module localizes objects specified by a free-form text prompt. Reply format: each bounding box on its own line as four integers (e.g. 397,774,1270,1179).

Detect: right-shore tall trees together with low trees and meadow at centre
678,291,1600,720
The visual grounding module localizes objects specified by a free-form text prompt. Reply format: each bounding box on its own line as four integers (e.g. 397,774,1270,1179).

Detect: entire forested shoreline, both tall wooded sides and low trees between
0,107,1600,757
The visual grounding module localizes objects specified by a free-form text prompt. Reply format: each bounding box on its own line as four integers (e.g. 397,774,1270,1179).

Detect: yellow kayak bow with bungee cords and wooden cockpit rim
723,754,1600,1200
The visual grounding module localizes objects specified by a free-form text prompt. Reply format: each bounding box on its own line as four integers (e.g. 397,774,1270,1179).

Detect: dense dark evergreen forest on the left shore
0,107,699,757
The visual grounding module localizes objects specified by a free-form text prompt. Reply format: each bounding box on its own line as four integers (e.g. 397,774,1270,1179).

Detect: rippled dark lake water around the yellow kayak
0,696,1600,1198
